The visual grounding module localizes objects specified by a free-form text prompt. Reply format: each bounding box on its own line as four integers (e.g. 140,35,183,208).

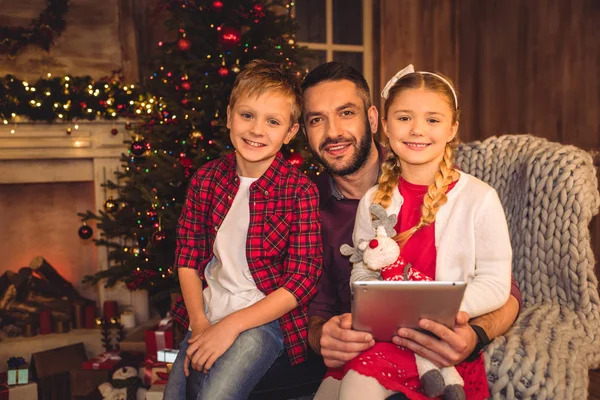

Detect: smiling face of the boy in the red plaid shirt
227,91,298,178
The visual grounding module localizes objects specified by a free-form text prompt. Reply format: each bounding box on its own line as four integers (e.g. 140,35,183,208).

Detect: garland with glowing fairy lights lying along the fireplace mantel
0,74,155,124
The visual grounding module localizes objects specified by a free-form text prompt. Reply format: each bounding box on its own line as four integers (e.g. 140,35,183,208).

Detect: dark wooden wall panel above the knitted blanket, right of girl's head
454,0,600,149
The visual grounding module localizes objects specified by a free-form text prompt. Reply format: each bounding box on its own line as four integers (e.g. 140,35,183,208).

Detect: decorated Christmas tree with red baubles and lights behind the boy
80,0,316,306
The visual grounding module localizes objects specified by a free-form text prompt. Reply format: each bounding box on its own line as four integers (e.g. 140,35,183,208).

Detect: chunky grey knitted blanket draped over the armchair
457,135,600,400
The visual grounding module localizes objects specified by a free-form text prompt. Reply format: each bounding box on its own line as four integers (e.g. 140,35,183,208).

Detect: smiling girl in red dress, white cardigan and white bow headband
316,65,512,399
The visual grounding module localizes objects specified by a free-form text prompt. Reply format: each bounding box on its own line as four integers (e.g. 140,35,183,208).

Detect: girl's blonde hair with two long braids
373,72,459,247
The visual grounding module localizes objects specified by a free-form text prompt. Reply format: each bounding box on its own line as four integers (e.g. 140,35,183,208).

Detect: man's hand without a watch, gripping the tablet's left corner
320,314,375,368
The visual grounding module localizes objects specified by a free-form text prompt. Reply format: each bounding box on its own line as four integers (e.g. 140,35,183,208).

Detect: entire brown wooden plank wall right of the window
382,0,600,275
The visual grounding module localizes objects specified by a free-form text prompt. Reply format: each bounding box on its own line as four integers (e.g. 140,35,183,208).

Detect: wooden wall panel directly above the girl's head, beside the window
380,0,458,112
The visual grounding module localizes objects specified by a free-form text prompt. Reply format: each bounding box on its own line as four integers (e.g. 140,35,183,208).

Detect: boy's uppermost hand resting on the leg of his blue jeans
187,317,240,374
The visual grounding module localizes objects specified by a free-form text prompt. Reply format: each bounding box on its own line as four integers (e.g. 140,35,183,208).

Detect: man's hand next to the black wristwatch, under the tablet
392,311,477,368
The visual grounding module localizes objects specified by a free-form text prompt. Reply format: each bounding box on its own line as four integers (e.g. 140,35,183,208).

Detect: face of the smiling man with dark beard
303,80,377,176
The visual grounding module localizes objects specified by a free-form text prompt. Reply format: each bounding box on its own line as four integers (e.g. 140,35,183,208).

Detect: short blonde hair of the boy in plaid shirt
229,60,302,125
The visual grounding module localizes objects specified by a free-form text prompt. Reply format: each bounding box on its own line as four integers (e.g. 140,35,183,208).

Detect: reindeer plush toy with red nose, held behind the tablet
340,204,465,400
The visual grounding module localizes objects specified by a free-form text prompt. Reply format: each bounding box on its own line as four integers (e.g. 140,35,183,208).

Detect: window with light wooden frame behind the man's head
294,0,374,93
